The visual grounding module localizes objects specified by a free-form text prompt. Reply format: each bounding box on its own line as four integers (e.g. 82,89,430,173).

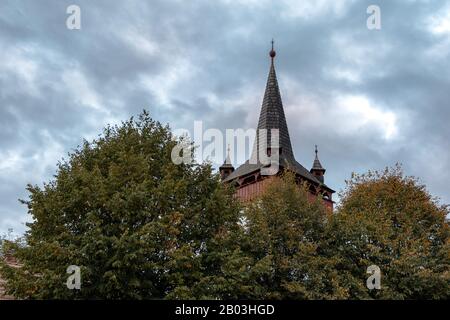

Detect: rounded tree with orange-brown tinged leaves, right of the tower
324,166,450,299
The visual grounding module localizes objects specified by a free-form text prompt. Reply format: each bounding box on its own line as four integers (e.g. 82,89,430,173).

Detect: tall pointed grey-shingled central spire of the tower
252,40,295,163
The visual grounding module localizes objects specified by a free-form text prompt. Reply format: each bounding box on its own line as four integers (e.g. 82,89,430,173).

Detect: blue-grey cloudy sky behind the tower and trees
0,0,450,234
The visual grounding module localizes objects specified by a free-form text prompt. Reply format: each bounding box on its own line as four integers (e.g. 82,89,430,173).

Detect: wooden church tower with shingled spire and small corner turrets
220,41,335,210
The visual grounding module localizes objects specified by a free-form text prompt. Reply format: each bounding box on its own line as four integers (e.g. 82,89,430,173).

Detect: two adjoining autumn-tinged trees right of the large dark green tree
207,167,450,299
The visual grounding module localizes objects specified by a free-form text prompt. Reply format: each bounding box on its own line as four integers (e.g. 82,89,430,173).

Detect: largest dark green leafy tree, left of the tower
1,111,243,299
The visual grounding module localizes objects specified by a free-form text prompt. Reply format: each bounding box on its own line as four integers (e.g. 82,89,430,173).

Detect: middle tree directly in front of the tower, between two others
216,172,352,299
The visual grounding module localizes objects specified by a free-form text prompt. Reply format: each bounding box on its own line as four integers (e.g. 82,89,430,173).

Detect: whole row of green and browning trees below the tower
0,112,450,299
